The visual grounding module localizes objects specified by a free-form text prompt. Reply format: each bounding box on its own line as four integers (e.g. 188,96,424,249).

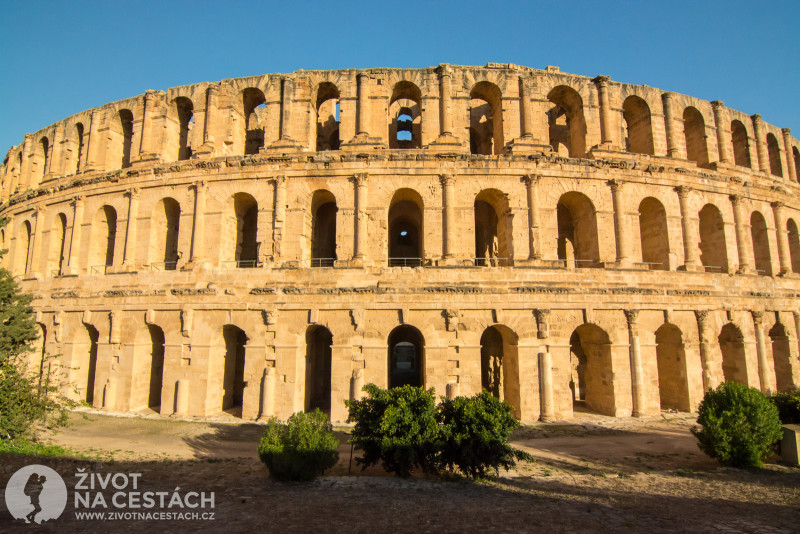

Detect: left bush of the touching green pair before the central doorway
345,384,441,477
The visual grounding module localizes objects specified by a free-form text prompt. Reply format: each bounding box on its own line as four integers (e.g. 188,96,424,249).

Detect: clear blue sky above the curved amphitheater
0,0,800,155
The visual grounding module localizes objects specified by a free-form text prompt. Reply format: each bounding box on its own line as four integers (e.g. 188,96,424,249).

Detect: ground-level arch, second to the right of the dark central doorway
569,324,616,416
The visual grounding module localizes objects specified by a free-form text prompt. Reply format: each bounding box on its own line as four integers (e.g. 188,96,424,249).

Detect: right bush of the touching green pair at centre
439,389,532,478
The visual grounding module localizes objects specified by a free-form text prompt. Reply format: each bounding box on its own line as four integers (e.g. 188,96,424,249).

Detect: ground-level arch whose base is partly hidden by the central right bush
481,325,520,418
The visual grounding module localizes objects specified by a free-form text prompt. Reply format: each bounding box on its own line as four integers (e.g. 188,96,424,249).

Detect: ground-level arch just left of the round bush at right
656,323,691,412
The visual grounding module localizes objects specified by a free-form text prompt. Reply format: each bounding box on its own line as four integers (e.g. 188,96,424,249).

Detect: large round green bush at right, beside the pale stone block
692,382,781,467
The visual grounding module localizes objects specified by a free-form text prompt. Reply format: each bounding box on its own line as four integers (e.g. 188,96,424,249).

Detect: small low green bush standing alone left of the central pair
258,410,339,480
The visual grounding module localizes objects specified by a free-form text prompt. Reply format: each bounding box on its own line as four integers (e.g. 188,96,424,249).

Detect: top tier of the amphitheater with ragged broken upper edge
0,63,800,201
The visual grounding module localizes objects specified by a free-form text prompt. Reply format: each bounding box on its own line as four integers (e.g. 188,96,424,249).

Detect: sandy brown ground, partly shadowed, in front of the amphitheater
0,411,800,533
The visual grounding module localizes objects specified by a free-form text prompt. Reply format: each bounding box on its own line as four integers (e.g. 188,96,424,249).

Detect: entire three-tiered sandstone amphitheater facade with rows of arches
0,64,800,421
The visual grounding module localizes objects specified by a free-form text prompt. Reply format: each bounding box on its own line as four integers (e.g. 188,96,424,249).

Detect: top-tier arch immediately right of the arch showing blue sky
469,82,505,155
